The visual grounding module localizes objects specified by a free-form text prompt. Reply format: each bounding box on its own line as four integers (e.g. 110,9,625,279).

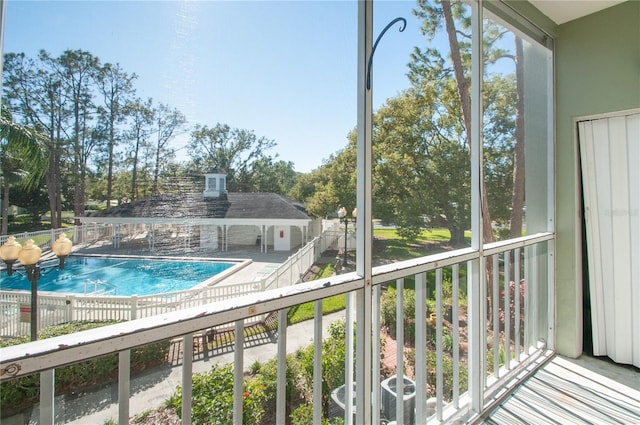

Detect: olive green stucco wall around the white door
554,0,640,357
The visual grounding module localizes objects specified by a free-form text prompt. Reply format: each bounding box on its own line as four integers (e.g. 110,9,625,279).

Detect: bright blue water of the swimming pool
0,256,234,295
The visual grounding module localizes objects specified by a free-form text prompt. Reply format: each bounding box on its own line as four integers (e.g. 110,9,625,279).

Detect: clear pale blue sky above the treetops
4,0,425,172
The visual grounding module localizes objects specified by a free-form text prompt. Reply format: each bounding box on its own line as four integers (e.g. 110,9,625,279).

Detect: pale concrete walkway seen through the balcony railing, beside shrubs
12,311,344,425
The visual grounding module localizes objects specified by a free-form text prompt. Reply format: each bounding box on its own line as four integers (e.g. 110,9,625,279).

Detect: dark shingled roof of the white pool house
87,193,309,220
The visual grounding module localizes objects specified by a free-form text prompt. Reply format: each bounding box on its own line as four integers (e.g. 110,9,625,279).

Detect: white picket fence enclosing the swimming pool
0,226,338,337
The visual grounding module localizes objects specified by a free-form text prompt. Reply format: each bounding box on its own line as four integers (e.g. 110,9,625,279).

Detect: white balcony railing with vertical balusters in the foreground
0,233,554,424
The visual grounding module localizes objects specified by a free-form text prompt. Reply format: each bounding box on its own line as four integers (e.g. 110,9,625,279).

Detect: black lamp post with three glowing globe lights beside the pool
0,233,73,341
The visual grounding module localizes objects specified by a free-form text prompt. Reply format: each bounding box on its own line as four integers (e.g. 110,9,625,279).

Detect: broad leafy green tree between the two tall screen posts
373,80,471,245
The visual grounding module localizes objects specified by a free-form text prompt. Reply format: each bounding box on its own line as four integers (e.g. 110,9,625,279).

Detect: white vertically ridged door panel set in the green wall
578,113,640,367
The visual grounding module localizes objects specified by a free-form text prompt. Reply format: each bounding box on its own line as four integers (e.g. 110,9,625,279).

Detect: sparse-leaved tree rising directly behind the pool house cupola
189,124,276,192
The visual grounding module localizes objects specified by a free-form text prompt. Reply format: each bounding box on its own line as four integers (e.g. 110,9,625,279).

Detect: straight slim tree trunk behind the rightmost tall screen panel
509,37,525,238
